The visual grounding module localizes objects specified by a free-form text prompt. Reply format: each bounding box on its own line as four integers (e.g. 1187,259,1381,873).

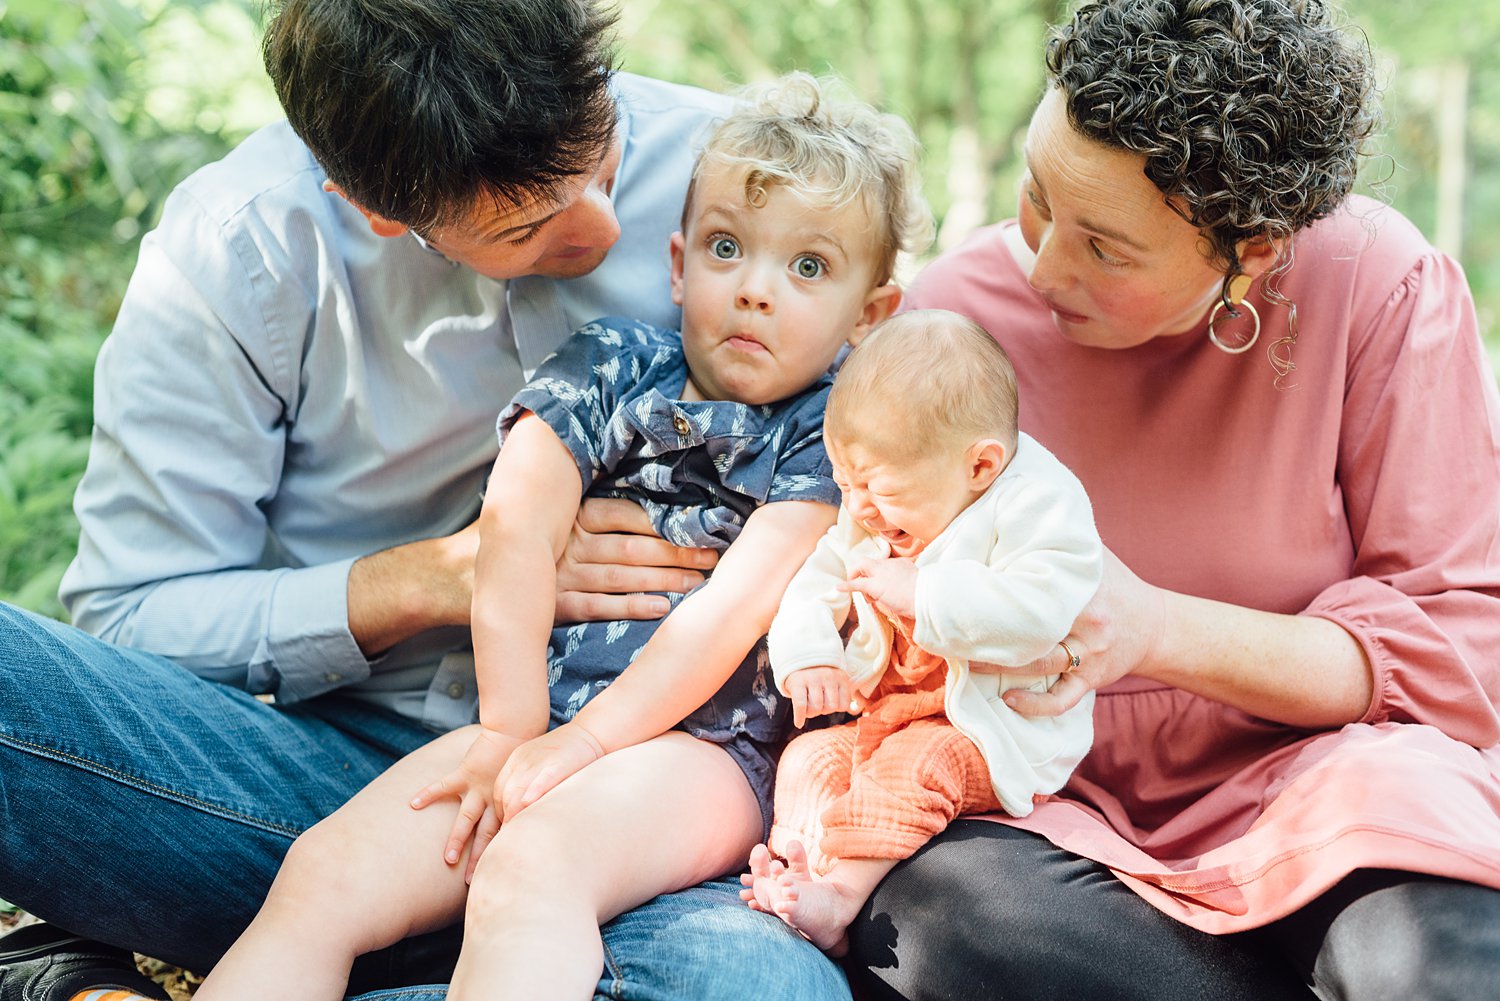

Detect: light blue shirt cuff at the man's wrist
261,560,371,702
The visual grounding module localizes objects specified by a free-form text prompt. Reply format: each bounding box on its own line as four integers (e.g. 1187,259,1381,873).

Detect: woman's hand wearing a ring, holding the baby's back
1004,549,1167,716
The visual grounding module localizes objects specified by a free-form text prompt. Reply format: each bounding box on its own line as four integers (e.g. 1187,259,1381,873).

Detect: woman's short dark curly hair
1047,0,1380,290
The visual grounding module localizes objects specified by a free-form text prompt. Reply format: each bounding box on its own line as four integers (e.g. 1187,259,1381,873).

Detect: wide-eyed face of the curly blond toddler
672,170,896,404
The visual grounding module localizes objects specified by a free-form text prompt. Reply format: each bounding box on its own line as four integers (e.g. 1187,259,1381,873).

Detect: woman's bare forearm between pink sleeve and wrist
1136,591,1374,728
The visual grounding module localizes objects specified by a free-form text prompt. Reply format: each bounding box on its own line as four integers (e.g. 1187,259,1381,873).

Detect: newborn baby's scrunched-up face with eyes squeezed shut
825,438,984,557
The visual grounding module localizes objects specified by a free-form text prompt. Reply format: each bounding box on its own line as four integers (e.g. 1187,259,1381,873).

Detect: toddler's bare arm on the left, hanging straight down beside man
411,414,584,861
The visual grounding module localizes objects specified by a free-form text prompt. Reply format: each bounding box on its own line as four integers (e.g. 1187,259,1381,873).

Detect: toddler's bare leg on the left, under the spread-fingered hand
195,728,474,1001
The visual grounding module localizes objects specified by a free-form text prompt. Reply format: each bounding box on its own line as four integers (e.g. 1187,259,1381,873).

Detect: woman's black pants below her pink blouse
848,819,1500,1001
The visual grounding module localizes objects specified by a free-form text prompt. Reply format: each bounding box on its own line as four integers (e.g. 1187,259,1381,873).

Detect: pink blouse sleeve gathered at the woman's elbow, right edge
1307,254,1500,747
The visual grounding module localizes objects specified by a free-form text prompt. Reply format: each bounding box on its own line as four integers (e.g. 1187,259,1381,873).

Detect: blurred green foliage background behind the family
0,0,1500,615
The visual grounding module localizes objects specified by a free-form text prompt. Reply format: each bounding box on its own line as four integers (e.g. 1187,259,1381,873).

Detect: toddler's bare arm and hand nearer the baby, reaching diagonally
500,501,834,818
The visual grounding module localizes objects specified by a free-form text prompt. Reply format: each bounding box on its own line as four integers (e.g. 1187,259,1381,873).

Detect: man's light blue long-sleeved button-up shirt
62,74,728,729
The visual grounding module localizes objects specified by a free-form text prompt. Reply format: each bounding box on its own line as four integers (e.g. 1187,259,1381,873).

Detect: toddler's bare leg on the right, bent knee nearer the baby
449,732,761,1001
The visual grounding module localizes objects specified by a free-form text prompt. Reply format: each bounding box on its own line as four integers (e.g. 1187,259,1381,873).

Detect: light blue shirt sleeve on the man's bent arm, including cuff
62,192,369,701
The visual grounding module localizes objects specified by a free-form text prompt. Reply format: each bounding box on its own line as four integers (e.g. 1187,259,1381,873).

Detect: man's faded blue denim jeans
0,603,849,1001
